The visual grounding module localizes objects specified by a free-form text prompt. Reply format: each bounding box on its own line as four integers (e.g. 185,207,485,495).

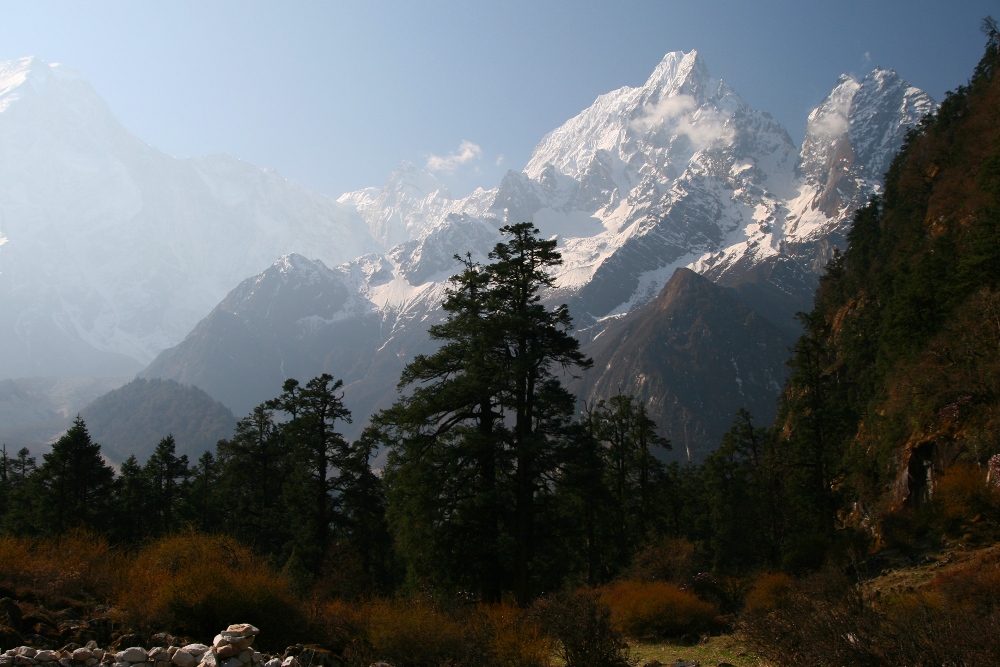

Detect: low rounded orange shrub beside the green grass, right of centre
601,581,717,639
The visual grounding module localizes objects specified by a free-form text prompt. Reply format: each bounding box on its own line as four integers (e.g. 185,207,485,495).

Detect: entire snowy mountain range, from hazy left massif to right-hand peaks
0,51,934,454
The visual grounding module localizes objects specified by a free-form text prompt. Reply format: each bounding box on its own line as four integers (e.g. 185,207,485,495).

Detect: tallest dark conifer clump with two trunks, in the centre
376,223,590,604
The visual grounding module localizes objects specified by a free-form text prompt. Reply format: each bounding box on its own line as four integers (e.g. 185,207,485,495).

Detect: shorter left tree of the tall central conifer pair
376,256,506,602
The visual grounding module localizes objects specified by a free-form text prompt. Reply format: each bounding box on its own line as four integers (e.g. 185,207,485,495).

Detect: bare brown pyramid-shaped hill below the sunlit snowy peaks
573,269,793,461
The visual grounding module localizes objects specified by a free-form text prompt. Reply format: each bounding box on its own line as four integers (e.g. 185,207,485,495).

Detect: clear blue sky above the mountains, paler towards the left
0,0,1000,196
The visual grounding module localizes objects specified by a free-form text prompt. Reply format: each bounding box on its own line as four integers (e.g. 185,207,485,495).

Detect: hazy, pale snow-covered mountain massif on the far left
0,58,380,378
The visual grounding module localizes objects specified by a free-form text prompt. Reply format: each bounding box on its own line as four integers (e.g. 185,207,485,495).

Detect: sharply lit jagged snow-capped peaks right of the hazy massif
328,51,935,324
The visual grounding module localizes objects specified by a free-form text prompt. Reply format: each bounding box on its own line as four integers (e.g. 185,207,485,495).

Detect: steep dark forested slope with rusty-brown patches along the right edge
777,26,1000,528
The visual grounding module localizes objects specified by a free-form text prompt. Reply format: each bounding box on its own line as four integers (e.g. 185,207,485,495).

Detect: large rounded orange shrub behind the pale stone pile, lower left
115,533,308,648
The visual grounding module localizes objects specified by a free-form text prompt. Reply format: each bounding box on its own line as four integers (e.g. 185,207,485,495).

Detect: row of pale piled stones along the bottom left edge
0,623,326,667
